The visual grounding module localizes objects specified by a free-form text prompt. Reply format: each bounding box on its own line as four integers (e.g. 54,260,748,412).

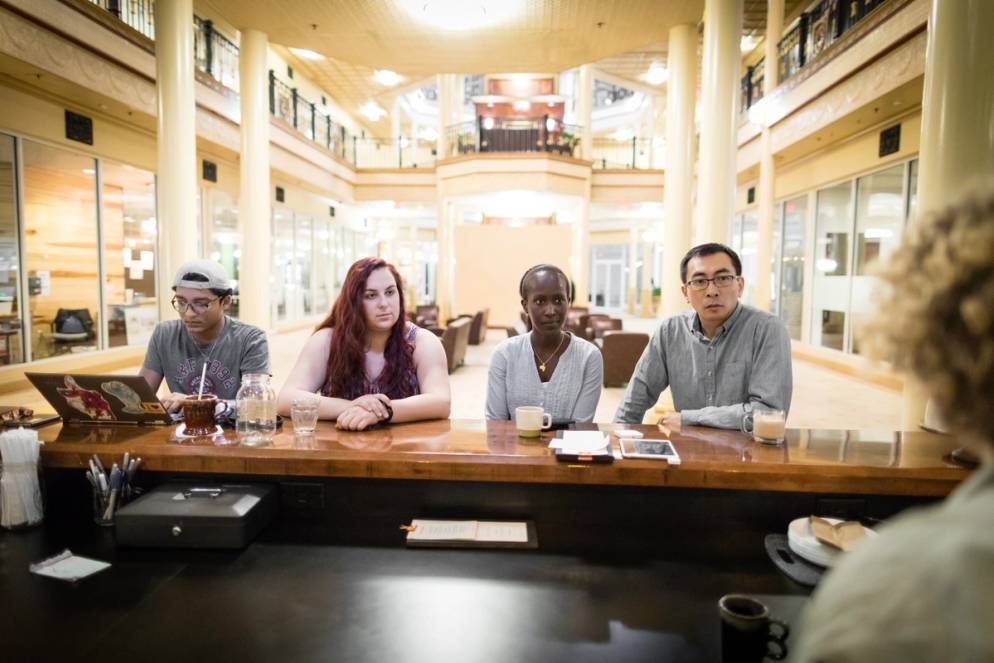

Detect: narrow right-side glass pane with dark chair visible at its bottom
811,181,853,350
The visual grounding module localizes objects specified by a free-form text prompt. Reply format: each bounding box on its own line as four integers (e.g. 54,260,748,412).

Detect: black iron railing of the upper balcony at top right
740,0,888,112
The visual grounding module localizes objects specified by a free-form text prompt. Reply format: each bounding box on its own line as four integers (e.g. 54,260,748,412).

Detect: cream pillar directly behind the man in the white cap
155,0,199,320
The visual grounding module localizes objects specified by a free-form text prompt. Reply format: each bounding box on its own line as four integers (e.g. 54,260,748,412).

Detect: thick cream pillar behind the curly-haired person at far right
901,0,994,430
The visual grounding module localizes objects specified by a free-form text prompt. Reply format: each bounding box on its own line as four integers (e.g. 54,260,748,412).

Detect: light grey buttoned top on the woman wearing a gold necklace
486,332,604,422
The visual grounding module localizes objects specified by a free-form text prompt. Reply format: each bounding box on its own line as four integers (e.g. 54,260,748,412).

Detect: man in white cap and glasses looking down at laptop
139,259,269,412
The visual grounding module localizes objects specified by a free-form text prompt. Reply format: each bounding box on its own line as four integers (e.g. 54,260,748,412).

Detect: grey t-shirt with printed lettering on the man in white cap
144,316,269,400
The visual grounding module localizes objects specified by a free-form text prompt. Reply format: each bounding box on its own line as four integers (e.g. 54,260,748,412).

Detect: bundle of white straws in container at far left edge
0,428,43,528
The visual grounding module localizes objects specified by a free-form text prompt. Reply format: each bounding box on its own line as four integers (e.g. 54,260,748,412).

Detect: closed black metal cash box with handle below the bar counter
115,483,278,548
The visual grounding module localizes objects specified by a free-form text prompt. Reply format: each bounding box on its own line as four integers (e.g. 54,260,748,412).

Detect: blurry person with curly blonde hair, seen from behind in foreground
798,181,994,663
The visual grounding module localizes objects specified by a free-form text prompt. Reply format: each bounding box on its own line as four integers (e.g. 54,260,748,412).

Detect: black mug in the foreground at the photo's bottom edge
718,594,790,663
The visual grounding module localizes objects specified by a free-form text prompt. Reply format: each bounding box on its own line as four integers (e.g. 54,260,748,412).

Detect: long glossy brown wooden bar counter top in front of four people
39,420,969,497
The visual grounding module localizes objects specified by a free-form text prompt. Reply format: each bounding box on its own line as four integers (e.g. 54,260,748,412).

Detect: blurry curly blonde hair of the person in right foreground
864,180,994,444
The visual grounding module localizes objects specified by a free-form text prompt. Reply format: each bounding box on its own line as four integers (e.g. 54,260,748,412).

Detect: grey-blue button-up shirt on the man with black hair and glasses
615,302,793,428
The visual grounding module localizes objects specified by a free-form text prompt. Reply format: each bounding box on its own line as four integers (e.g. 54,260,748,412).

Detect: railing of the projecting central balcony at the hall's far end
445,115,582,156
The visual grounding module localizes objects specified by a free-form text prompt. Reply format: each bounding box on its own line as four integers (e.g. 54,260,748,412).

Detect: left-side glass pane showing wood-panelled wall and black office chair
22,140,100,359
